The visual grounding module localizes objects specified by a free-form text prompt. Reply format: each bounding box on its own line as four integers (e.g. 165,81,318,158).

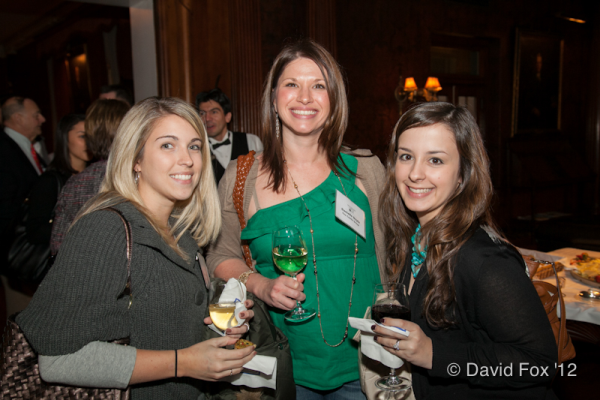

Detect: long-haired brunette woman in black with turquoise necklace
375,103,557,399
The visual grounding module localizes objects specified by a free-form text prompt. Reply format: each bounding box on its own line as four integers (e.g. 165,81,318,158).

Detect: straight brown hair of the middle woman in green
261,39,354,192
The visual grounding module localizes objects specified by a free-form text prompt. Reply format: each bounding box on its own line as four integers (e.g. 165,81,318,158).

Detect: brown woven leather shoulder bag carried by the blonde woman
0,208,133,400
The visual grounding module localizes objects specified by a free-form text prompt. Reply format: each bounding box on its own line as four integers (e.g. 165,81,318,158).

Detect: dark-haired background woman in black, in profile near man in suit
26,114,90,244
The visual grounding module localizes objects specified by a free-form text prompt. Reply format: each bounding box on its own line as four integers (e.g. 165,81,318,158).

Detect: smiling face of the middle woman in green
274,58,330,137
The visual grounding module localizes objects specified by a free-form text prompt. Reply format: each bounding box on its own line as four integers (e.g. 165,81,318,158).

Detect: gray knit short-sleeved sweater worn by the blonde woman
17,203,207,399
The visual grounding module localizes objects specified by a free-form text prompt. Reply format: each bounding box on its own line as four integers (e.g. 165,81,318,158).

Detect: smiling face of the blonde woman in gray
134,115,202,214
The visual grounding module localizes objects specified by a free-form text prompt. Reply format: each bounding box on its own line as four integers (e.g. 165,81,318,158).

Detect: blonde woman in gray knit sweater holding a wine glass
17,98,255,400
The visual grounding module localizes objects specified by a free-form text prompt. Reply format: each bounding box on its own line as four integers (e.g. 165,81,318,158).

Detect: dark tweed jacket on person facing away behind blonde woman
50,160,106,254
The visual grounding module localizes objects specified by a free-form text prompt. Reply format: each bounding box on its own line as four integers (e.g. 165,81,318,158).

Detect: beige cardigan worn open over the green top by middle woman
206,149,388,282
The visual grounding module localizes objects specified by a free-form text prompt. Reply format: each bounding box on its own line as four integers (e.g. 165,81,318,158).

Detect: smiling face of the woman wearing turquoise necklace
394,124,461,226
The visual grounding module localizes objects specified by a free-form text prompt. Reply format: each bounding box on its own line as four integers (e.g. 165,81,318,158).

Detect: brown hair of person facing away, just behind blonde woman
85,99,130,161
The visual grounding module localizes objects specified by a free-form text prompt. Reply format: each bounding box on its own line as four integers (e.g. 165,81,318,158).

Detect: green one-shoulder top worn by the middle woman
241,154,381,390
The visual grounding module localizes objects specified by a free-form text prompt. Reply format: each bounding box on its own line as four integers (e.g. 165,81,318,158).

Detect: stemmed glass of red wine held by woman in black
371,282,411,391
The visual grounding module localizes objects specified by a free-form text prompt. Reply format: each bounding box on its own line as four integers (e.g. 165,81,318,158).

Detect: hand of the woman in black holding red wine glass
373,318,433,369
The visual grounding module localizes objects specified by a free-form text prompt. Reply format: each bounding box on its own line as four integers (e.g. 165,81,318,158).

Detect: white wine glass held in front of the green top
272,226,315,322
